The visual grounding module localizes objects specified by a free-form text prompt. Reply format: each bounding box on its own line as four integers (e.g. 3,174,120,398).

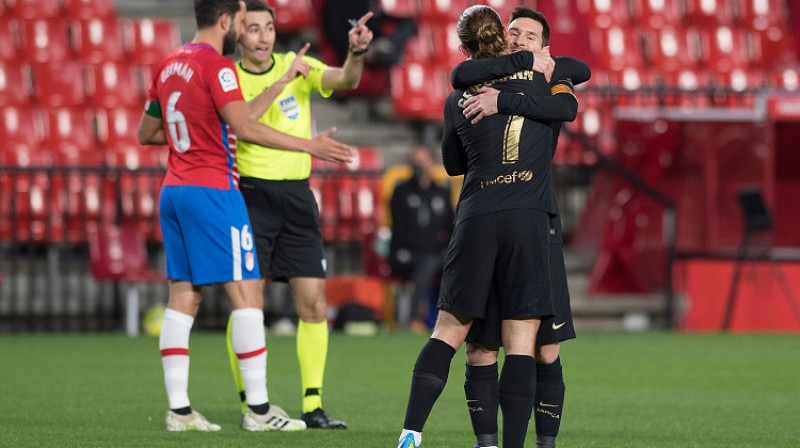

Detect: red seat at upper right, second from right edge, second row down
700,26,750,72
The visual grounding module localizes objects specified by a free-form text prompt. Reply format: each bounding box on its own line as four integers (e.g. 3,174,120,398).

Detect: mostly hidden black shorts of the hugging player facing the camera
466,220,575,347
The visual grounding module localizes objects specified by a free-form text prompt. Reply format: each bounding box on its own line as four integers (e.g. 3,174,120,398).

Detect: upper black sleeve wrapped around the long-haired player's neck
450,51,532,90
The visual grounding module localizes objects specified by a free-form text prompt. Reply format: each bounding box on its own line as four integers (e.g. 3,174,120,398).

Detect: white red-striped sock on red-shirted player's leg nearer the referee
231,308,269,405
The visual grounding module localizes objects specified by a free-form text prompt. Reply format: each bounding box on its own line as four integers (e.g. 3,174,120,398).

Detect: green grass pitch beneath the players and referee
0,332,800,448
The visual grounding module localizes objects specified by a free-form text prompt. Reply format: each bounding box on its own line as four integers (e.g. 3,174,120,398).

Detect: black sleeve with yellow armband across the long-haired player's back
497,81,578,121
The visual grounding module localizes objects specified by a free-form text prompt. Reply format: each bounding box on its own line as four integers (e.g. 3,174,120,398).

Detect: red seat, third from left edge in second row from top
72,17,125,64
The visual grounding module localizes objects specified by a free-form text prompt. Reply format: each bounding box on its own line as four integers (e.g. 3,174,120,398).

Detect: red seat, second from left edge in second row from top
19,17,72,65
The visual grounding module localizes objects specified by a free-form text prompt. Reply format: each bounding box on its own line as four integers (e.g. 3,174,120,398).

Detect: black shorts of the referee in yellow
239,177,325,282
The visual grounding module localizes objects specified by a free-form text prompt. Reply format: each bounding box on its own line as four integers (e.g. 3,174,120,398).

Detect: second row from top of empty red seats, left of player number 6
0,16,180,65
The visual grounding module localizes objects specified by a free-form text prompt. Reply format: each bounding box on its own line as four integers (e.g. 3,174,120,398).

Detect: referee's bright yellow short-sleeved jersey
236,51,333,180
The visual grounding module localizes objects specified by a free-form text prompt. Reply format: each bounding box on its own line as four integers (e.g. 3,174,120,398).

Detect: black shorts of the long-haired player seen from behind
438,209,554,319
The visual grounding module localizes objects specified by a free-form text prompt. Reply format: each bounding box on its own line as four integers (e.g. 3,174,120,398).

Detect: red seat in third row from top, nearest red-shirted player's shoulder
86,62,144,110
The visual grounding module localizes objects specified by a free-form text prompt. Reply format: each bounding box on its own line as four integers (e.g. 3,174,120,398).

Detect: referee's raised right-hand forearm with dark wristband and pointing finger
322,12,373,90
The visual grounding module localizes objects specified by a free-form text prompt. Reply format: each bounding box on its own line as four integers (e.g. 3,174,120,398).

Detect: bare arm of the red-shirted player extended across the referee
220,101,355,163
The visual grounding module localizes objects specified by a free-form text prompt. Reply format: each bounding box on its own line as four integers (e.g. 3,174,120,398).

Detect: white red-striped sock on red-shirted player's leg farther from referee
158,308,194,409
